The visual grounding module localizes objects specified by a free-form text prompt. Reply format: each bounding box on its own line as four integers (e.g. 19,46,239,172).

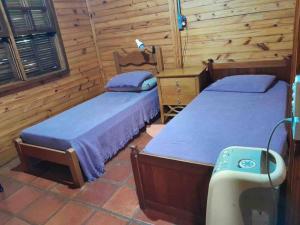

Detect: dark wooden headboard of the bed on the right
208,60,291,83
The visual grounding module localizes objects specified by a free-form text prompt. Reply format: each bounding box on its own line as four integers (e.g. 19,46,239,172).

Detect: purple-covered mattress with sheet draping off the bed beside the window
21,88,159,181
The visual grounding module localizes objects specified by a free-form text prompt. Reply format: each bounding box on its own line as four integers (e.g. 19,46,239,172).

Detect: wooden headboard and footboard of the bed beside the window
15,46,163,187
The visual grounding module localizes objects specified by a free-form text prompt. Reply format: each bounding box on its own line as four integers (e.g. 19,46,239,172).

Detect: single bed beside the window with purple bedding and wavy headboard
16,47,162,186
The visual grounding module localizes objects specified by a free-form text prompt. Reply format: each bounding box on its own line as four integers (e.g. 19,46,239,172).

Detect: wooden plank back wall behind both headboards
87,0,295,75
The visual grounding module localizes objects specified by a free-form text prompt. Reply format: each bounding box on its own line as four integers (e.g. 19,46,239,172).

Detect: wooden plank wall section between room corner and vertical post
87,0,176,80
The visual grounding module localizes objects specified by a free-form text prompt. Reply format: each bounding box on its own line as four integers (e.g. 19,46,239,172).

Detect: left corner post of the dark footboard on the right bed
130,145,145,209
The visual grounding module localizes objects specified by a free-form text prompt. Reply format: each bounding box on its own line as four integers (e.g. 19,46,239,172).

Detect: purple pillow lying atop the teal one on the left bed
105,71,153,91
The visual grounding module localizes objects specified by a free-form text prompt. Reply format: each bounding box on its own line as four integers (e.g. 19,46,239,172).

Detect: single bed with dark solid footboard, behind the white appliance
131,61,290,224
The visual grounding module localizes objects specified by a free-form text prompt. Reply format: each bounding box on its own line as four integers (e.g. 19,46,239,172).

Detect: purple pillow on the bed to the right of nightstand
205,75,276,93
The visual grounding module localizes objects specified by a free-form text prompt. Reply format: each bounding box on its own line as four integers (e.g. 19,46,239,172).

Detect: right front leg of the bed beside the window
66,148,84,187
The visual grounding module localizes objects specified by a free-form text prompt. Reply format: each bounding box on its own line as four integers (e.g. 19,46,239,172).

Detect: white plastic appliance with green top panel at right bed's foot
206,146,286,225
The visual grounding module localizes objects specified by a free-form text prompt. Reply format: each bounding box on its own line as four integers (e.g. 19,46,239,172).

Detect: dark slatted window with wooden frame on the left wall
0,0,68,93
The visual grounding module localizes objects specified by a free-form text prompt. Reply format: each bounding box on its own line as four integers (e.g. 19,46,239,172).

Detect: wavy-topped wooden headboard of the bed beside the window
113,46,164,73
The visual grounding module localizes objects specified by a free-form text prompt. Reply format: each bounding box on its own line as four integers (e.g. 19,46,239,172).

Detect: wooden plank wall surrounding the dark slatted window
0,0,103,165
